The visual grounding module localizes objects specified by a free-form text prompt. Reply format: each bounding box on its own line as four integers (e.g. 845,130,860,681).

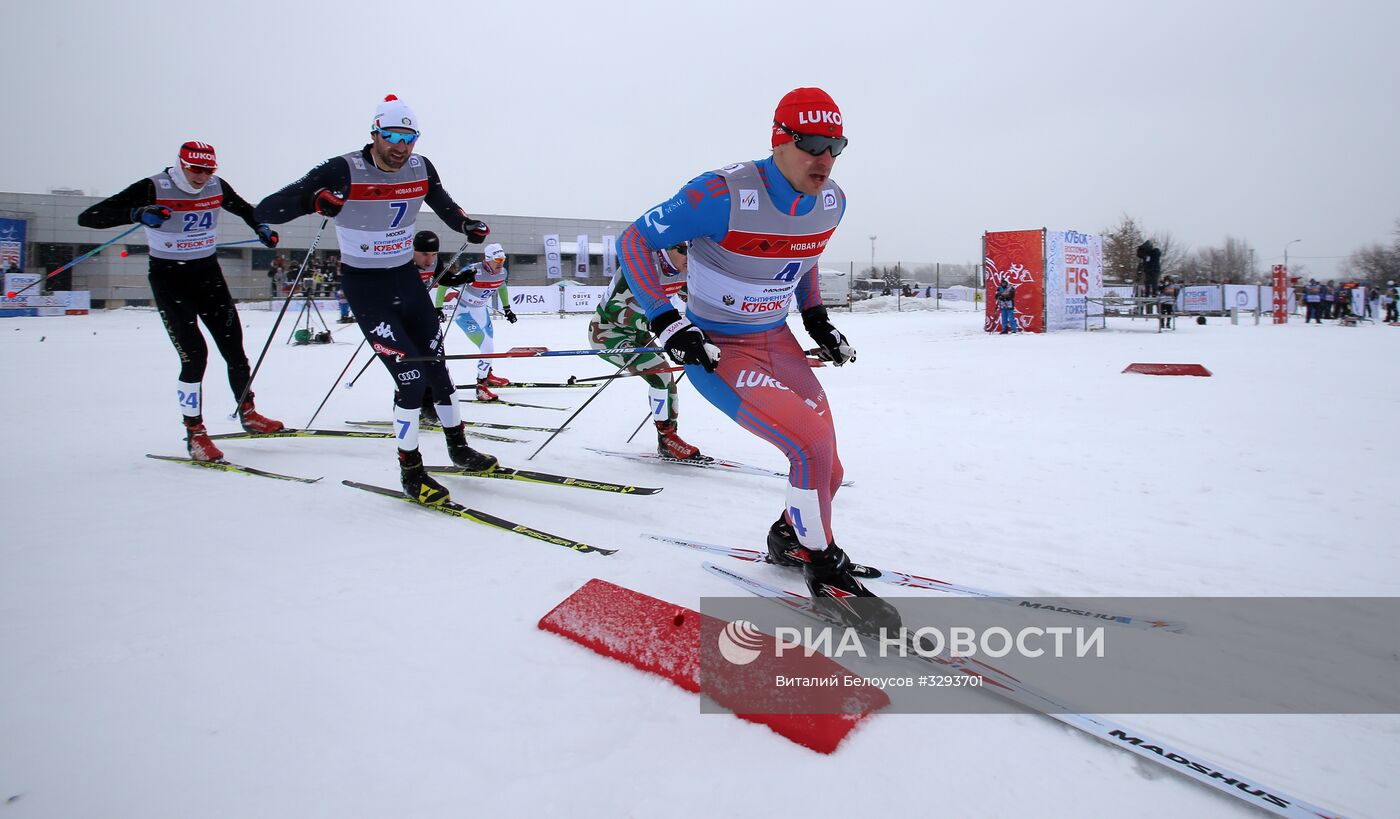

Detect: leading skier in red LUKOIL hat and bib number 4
619,88,899,627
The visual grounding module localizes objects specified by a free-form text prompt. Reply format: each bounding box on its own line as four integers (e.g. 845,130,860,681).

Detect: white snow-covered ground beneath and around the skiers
0,303,1400,819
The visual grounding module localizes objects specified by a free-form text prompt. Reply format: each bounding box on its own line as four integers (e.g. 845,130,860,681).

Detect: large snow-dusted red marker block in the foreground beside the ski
539,578,889,753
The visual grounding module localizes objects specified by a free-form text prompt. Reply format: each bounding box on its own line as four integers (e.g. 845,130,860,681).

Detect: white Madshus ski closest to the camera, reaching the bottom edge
704,563,1340,819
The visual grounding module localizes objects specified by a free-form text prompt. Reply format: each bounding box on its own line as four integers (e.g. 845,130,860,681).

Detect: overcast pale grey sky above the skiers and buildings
0,0,1400,273
